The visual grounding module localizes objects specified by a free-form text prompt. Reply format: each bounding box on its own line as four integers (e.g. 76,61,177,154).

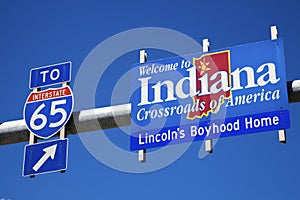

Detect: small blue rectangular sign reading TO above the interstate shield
29,62,71,89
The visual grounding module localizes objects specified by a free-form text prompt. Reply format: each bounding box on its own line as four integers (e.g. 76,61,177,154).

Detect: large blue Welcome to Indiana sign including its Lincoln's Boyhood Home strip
130,39,290,150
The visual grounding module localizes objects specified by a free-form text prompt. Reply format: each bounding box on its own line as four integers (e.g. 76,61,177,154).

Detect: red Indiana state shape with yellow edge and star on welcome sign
187,50,231,120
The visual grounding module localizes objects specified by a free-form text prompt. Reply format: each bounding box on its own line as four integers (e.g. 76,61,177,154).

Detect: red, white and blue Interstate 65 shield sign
23,86,73,139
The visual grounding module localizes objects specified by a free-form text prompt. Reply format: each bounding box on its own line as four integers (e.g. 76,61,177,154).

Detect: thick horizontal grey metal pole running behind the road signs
0,80,300,145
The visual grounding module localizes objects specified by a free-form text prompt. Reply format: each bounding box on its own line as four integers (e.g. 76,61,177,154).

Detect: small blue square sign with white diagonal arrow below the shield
23,139,68,176
